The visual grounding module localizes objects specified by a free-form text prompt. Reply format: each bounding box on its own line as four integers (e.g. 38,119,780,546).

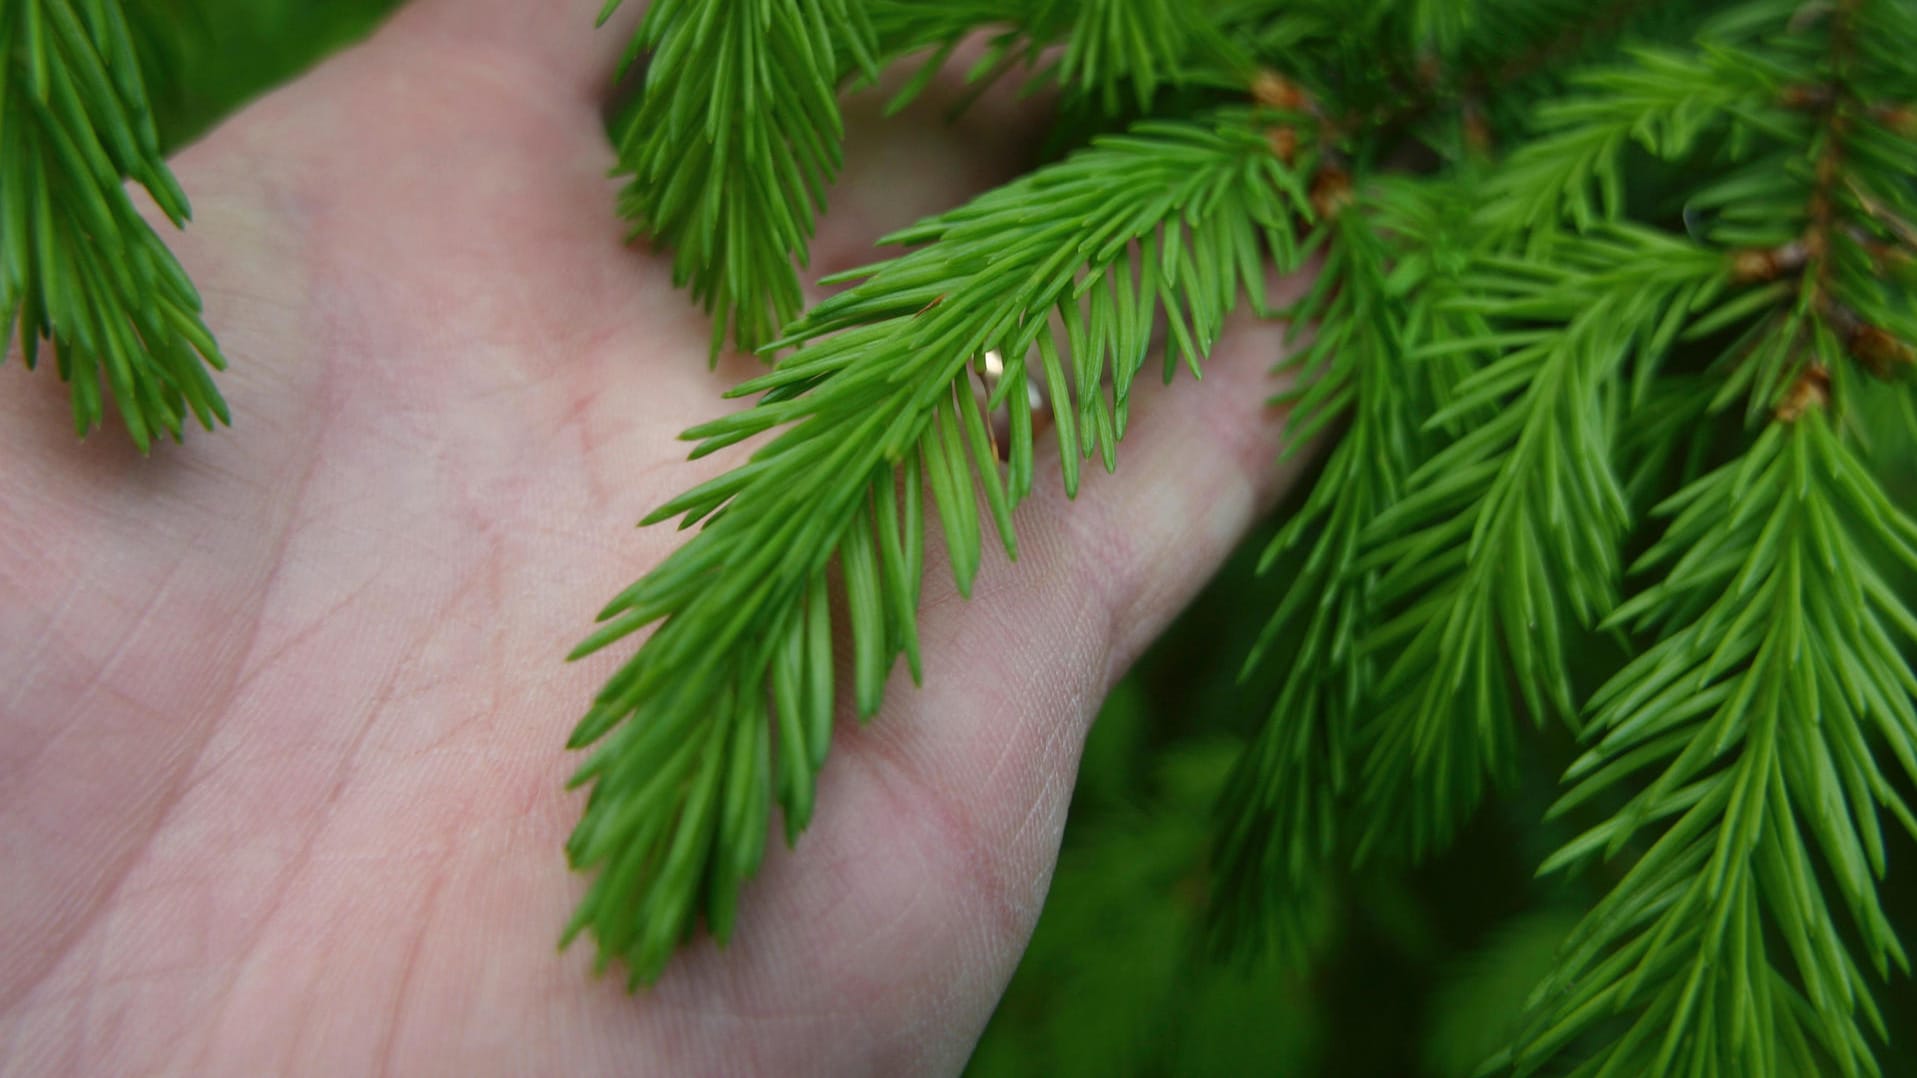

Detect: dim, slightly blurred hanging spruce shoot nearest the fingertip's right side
1212,180,1482,953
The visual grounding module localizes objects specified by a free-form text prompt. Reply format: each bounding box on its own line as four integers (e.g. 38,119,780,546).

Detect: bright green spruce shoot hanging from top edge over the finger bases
600,0,876,363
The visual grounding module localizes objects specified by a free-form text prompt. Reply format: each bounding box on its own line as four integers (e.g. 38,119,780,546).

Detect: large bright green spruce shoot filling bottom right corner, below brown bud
1513,409,1917,1074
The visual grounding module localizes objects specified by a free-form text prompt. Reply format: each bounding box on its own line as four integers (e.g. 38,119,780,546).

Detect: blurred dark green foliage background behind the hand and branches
146,0,1917,1076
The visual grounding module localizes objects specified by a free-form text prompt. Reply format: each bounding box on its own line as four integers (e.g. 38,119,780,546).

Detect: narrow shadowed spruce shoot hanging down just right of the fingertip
1212,213,1411,951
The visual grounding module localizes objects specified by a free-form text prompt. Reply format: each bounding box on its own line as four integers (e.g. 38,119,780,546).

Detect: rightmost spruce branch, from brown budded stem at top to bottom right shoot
1509,2,1917,1074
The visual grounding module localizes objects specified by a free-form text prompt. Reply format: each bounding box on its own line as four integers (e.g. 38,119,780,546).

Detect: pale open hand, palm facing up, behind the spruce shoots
0,0,1288,1074
